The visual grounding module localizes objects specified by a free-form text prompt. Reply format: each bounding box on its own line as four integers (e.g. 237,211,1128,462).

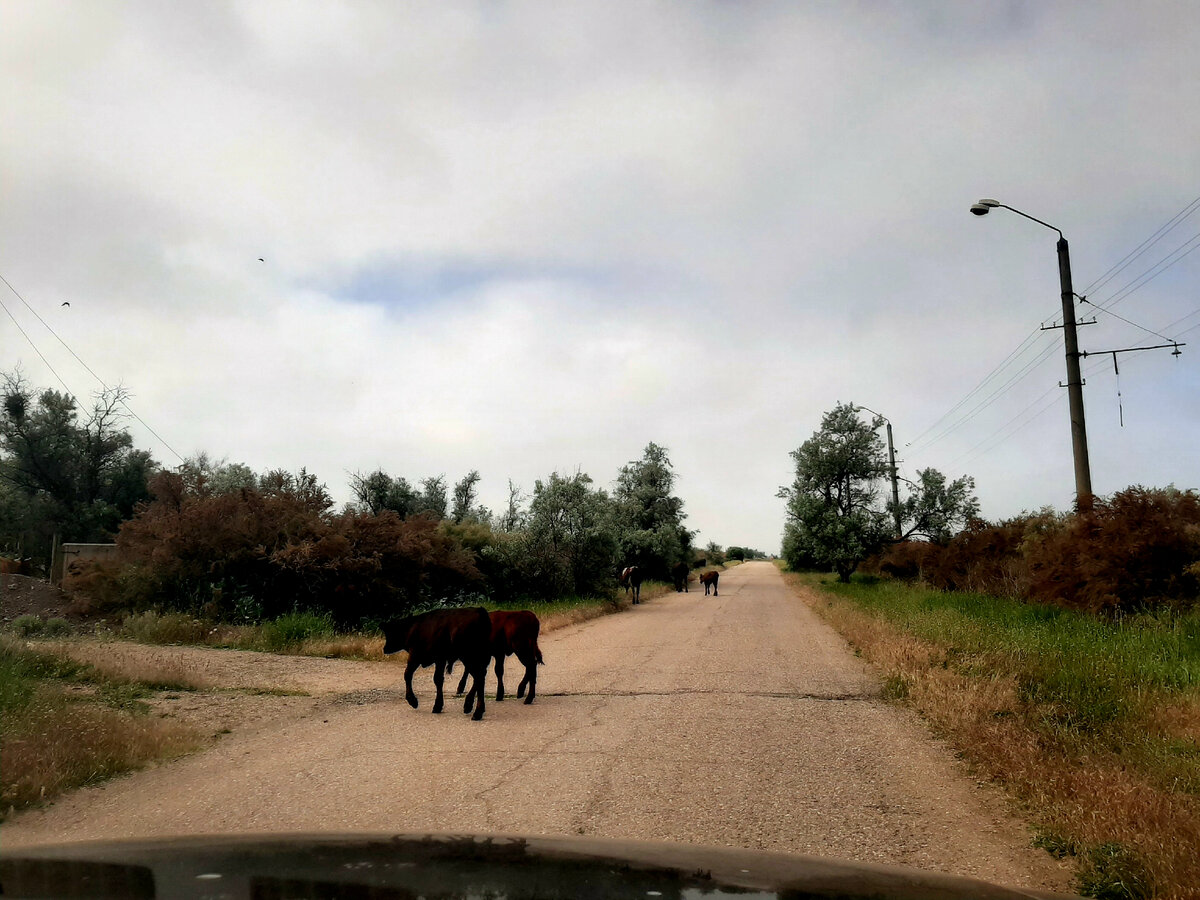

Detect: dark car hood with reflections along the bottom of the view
0,834,1089,900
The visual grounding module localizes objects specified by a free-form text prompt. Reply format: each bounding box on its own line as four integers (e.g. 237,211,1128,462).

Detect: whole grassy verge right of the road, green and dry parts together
786,574,1200,898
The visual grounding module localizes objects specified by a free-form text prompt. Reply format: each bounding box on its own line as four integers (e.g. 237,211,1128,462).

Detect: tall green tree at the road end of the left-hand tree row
613,442,694,580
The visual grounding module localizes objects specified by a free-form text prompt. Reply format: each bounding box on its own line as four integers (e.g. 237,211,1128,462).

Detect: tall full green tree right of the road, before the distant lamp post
779,403,889,581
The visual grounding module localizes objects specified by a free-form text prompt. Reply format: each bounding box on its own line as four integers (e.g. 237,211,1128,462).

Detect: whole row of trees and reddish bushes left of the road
0,373,710,625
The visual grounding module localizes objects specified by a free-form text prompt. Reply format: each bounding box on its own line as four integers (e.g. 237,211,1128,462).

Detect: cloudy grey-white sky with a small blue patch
0,0,1200,551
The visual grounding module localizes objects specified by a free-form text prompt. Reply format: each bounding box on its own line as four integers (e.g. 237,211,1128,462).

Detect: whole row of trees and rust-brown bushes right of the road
780,403,1200,616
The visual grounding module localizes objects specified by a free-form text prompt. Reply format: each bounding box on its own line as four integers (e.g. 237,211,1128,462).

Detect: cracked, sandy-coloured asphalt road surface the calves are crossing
0,563,1069,890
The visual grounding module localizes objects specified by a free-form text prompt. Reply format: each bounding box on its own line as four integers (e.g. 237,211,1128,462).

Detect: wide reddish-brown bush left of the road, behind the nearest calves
76,474,479,628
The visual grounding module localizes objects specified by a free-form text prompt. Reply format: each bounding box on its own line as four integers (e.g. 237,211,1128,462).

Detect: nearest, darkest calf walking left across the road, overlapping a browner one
383,606,492,721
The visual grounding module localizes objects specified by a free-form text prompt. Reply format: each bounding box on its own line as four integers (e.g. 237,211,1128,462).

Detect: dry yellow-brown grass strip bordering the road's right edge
785,574,1200,900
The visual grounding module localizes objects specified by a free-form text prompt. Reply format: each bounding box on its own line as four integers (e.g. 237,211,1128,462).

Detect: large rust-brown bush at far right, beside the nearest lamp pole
1026,486,1200,614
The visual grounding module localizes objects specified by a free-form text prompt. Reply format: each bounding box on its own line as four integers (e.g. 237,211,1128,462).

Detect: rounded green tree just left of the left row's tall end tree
526,472,617,599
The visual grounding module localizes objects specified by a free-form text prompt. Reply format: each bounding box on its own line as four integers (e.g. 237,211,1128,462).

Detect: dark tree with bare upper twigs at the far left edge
0,372,157,558
